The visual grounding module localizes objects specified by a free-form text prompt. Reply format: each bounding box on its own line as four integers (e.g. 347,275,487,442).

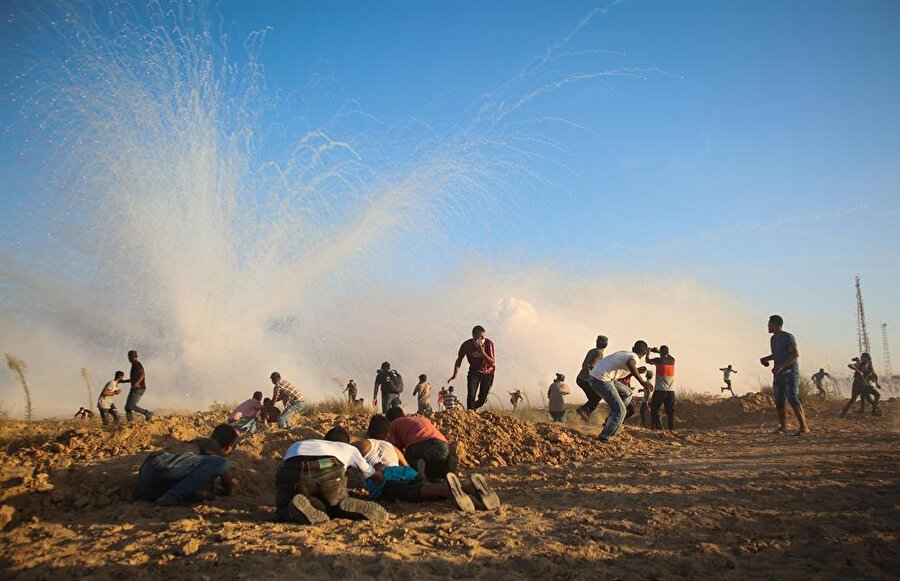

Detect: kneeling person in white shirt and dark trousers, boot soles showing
275,426,387,524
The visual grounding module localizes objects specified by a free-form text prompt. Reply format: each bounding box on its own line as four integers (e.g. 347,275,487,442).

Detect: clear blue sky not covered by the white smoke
0,0,900,402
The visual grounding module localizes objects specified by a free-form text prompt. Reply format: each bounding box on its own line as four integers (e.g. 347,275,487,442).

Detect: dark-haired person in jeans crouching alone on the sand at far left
138,424,238,506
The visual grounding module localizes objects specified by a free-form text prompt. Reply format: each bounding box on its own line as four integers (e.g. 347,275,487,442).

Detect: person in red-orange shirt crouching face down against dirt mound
387,407,457,480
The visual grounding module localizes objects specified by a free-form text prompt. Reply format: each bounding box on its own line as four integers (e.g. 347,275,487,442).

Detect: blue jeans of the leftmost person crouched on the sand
138,452,228,502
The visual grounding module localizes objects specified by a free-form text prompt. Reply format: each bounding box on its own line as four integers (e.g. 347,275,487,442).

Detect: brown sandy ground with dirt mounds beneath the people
0,394,900,579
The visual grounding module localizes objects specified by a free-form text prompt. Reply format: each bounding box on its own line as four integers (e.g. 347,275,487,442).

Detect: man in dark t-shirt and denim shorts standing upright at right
759,315,809,436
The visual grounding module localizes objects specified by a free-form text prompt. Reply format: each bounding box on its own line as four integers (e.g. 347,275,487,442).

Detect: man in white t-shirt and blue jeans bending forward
590,341,653,442
